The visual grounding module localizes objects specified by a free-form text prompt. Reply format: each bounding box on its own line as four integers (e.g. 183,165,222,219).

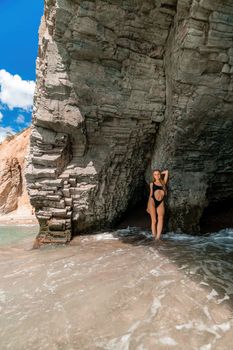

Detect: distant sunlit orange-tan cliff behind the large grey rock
0,128,33,222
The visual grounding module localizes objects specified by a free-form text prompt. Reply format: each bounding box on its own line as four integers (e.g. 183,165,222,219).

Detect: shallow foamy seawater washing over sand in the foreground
0,227,233,350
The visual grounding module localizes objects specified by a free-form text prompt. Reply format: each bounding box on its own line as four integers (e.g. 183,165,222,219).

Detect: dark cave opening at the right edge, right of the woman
200,198,233,233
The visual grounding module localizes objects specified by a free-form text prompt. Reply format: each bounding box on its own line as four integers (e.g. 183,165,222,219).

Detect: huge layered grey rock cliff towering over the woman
26,0,233,242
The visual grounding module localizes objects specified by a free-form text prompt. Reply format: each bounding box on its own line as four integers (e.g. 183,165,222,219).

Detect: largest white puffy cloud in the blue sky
0,69,35,111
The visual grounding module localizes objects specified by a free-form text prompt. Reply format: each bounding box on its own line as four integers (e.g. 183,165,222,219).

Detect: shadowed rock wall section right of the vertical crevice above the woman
147,0,233,233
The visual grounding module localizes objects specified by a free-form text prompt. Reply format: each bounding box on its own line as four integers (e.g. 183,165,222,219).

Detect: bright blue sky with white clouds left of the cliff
0,0,44,143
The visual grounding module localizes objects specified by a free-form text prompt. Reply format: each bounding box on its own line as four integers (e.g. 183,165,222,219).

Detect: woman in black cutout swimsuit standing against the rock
146,169,168,240
